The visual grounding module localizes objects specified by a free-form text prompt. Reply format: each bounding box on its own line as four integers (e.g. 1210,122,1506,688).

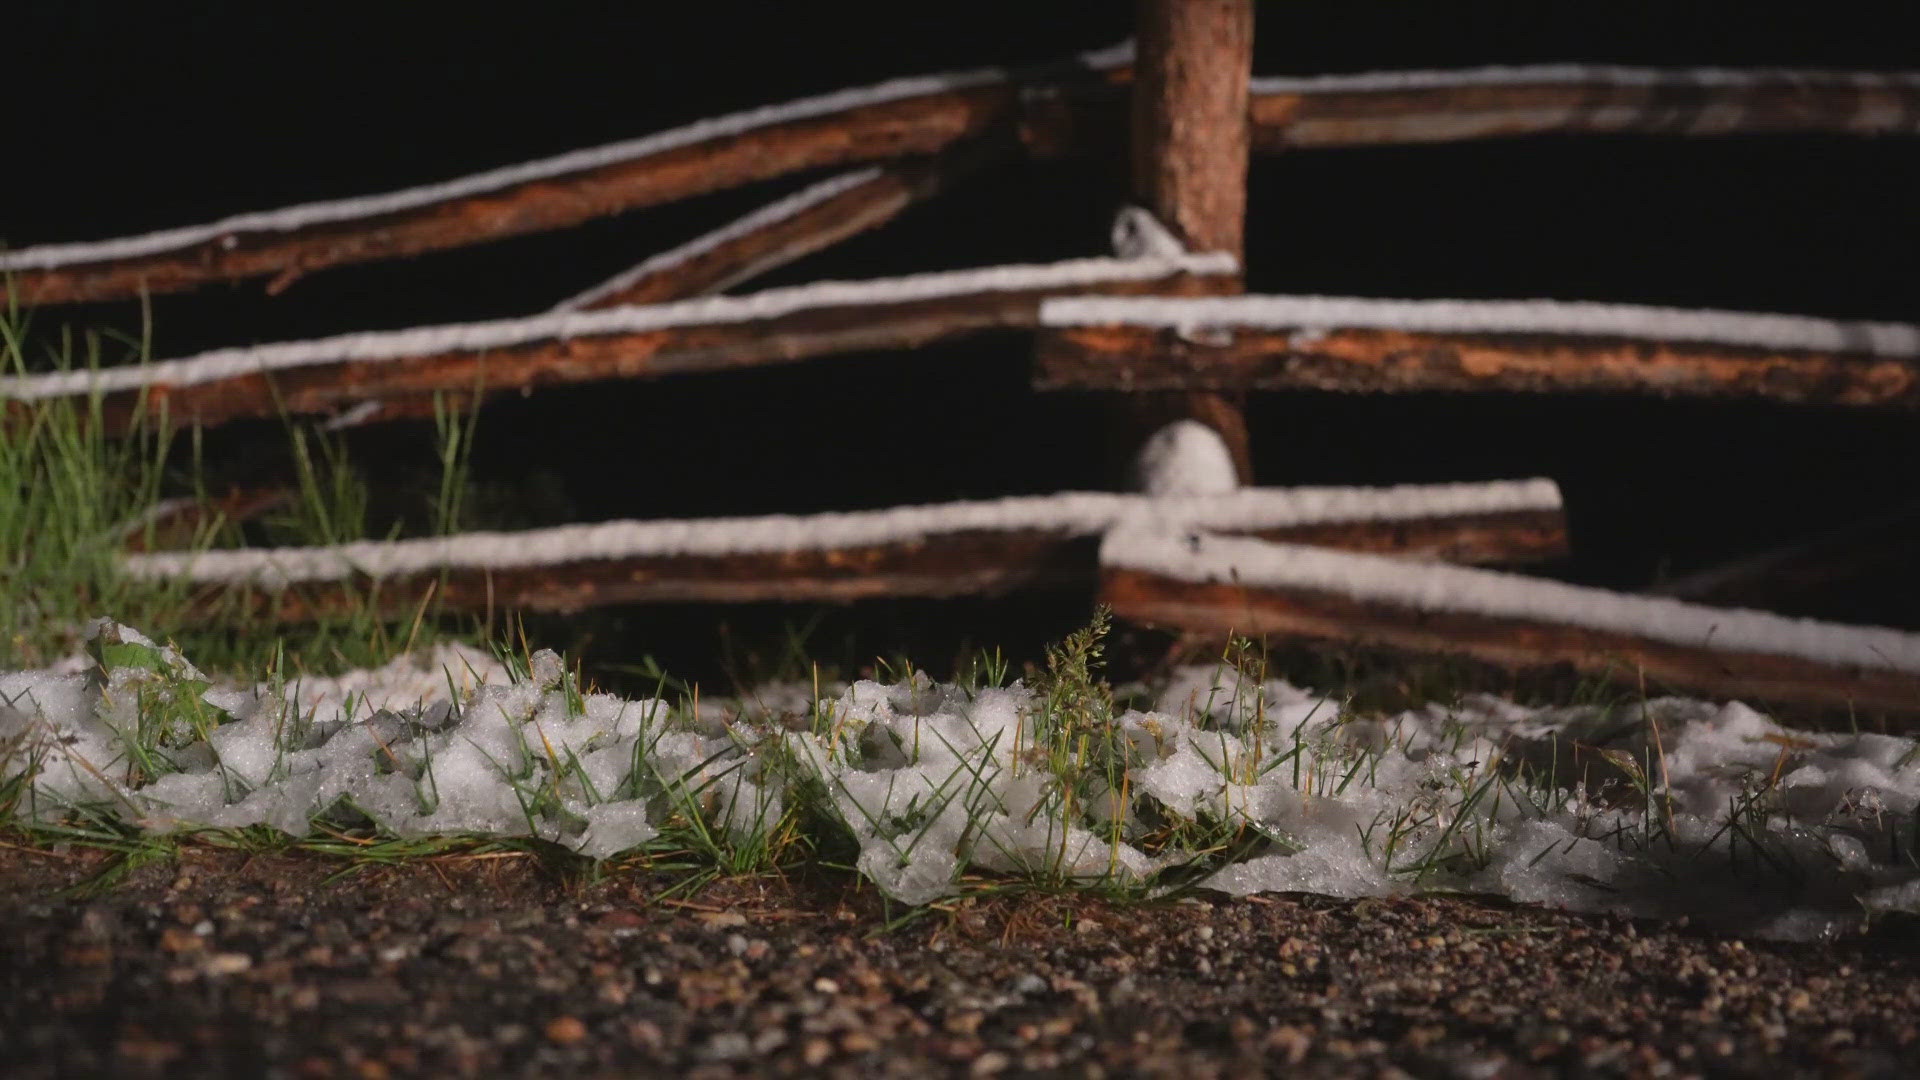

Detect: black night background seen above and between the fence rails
0,0,1920,680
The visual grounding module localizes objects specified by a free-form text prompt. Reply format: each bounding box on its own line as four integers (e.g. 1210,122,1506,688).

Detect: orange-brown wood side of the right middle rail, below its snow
1035,325,1920,407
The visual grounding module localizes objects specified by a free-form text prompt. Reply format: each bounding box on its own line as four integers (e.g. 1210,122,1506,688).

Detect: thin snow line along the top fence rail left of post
0,46,1131,271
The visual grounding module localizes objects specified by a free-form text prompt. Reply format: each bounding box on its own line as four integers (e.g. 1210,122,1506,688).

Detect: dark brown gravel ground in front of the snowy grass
0,847,1920,1078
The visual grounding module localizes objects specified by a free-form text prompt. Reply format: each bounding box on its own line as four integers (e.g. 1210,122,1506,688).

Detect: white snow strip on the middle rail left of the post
0,252,1236,400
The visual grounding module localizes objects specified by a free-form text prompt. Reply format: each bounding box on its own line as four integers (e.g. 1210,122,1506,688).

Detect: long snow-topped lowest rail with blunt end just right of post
121,480,1567,619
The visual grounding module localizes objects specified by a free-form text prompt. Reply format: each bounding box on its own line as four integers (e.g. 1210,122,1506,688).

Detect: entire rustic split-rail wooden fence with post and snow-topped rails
0,0,1920,717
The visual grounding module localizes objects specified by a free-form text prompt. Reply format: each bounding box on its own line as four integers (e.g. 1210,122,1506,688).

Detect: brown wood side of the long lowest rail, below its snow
145,511,1567,623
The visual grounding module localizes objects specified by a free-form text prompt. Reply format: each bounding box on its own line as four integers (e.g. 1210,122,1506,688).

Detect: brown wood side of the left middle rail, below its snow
45,273,1228,432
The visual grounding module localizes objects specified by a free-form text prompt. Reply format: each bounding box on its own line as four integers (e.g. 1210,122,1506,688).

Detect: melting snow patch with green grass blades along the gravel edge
0,621,1920,940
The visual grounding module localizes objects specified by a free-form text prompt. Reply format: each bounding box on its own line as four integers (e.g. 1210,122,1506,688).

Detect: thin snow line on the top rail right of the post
1250,63,1920,94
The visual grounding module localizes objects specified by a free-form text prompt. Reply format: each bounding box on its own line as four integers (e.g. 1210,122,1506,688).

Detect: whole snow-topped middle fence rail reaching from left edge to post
0,254,1236,429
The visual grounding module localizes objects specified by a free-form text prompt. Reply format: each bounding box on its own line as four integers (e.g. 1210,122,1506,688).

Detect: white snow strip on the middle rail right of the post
1041,296,1920,357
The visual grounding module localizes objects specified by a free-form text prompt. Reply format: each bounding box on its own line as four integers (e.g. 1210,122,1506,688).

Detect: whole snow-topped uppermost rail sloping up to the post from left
0,50,1127,304
